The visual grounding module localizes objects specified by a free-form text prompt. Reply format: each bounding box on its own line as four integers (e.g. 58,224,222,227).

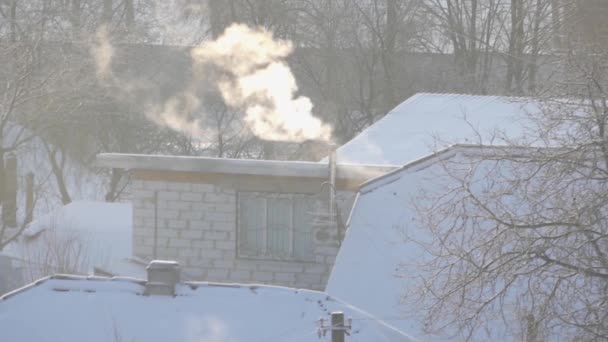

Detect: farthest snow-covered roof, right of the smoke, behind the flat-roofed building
337,93,541,165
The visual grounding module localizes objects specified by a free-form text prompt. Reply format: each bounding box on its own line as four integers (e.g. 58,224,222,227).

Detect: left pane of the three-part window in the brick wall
239,194,266,256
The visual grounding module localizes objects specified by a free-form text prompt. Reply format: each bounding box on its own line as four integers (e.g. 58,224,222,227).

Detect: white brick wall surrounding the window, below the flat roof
131,180,348,290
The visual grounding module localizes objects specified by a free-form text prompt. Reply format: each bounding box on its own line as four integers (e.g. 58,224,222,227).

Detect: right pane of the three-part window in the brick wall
294,196,314,260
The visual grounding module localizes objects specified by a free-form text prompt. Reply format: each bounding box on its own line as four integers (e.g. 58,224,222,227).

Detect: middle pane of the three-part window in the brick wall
268,196,292,258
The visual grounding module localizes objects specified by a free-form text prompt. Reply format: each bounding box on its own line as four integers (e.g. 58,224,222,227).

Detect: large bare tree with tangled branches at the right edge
416,16,608,341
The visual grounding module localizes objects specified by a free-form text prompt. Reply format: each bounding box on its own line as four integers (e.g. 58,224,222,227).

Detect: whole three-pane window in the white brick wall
238,192,315,261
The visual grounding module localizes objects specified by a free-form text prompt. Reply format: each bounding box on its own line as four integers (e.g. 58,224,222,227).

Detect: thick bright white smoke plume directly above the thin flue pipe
192,24,331,142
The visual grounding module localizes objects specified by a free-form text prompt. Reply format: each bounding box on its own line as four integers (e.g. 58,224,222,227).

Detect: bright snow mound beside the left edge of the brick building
6,201,134,278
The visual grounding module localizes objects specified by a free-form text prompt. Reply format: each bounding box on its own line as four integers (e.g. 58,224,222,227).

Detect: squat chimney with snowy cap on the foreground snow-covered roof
144,260,179,296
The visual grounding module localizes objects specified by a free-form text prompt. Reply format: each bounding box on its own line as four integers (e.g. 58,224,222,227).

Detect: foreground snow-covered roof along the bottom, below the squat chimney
0,276,410,342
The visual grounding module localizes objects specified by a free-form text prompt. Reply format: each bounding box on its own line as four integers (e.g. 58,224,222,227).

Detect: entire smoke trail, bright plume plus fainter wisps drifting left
90,24,332,142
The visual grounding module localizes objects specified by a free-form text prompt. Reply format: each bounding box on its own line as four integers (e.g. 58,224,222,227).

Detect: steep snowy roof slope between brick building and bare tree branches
326,145,523,340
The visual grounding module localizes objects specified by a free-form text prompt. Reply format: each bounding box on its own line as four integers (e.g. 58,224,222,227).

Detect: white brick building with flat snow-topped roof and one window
98,154,394,290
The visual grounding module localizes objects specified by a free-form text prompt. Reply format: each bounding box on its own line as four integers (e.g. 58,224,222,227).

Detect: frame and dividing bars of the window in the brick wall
235,190,317,263
